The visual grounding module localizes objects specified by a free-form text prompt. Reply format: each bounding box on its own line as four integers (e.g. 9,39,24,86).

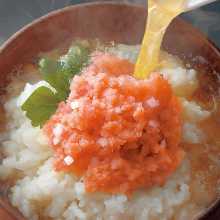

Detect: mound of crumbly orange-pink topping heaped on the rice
44,54,184,194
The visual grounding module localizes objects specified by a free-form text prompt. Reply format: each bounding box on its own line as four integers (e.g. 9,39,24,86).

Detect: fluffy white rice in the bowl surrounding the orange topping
0,47,210,220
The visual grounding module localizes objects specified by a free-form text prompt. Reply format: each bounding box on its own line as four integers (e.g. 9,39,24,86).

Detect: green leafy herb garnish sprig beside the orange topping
21,41,90,127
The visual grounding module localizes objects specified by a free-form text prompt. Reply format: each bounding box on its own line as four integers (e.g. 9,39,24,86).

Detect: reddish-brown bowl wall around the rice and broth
0,3,220,220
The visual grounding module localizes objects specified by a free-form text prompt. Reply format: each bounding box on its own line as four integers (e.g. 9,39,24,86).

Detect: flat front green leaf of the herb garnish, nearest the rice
21,86,59,127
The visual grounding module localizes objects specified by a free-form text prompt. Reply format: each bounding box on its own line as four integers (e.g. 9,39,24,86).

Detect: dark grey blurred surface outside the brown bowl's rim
0,0,220,220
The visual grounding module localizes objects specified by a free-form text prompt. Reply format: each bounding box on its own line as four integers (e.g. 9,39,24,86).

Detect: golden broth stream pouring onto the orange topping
134,0,185,79
